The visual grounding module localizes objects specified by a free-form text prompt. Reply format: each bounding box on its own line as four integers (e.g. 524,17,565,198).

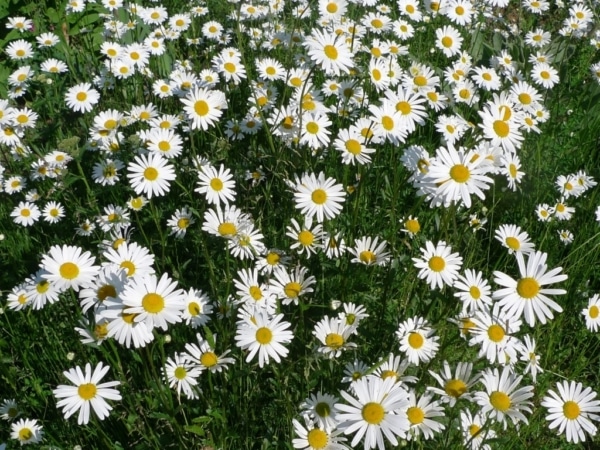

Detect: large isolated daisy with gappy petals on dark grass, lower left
52,362,121,425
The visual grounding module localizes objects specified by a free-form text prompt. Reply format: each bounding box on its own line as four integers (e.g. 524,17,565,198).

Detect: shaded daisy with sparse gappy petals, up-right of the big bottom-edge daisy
427,361,479,407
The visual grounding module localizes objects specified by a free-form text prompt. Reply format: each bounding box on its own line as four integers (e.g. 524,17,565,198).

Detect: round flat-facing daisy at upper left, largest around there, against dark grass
127,153,176,198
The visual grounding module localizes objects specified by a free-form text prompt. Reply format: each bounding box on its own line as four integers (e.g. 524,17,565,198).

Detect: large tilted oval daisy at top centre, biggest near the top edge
304,29,354,76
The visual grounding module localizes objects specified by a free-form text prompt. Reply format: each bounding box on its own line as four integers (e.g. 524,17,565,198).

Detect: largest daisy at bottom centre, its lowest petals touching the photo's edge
335,377,410,450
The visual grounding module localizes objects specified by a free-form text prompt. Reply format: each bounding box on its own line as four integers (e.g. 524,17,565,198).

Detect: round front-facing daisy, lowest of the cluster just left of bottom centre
235,311,294,368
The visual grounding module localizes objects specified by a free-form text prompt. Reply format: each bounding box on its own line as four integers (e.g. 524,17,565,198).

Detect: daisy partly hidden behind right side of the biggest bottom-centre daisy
406,390,446,441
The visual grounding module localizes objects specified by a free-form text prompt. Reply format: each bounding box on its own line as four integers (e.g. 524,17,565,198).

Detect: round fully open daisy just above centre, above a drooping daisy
294,172,346,223
